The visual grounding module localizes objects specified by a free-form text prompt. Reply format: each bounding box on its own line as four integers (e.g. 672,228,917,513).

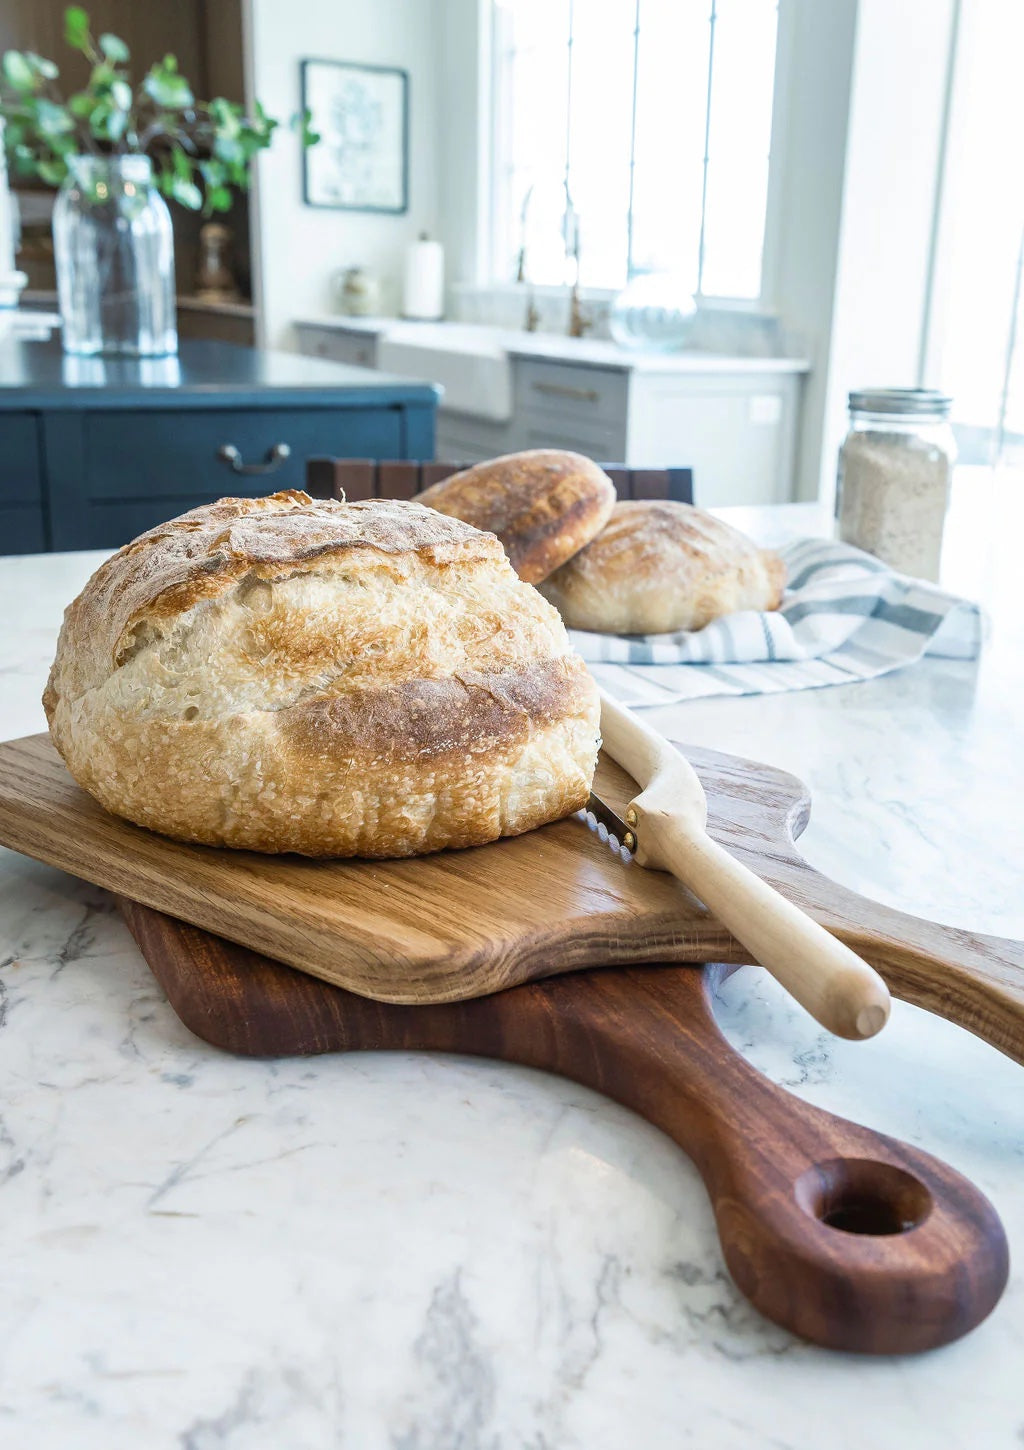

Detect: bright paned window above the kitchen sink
492,0,777,299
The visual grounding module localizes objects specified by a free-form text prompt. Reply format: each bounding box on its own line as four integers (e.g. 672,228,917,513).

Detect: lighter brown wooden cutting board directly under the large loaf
0,735,1024,1061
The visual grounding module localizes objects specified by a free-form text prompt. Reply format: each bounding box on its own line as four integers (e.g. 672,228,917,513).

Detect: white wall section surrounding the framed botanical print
245,0,442,348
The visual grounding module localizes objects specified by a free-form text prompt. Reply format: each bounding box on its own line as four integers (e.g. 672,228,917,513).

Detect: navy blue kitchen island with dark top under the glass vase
0,339,439,554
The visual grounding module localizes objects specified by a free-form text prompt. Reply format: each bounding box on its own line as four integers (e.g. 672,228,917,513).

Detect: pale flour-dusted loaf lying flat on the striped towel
540,499,786,634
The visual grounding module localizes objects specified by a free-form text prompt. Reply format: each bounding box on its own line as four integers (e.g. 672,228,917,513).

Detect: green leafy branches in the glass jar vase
0,6,319,215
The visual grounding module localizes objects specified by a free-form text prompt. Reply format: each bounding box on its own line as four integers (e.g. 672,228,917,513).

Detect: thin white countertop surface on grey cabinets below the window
294,313,811,374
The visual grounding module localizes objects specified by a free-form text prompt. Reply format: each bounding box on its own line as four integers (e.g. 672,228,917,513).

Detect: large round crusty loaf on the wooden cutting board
44,492,599,857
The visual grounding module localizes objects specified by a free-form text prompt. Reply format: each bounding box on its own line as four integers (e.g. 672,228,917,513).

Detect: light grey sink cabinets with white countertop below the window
294,316,809,508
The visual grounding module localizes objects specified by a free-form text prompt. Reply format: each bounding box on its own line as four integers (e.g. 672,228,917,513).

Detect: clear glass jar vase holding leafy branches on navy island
54,155,178,357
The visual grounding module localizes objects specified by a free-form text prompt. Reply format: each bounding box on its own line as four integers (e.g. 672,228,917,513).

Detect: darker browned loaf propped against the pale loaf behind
416,448,615,584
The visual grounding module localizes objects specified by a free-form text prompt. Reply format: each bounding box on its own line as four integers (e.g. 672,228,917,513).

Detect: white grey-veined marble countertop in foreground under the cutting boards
0,490,1024,1450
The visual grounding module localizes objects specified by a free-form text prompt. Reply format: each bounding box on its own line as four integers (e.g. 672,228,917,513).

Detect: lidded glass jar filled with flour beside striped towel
837,387,956,581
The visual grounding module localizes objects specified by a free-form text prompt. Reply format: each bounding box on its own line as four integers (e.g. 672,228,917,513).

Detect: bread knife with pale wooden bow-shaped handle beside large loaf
587,690,891,1040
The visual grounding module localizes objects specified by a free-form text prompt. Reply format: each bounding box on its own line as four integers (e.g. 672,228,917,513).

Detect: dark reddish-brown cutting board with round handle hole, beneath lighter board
120,899,1008,1354
